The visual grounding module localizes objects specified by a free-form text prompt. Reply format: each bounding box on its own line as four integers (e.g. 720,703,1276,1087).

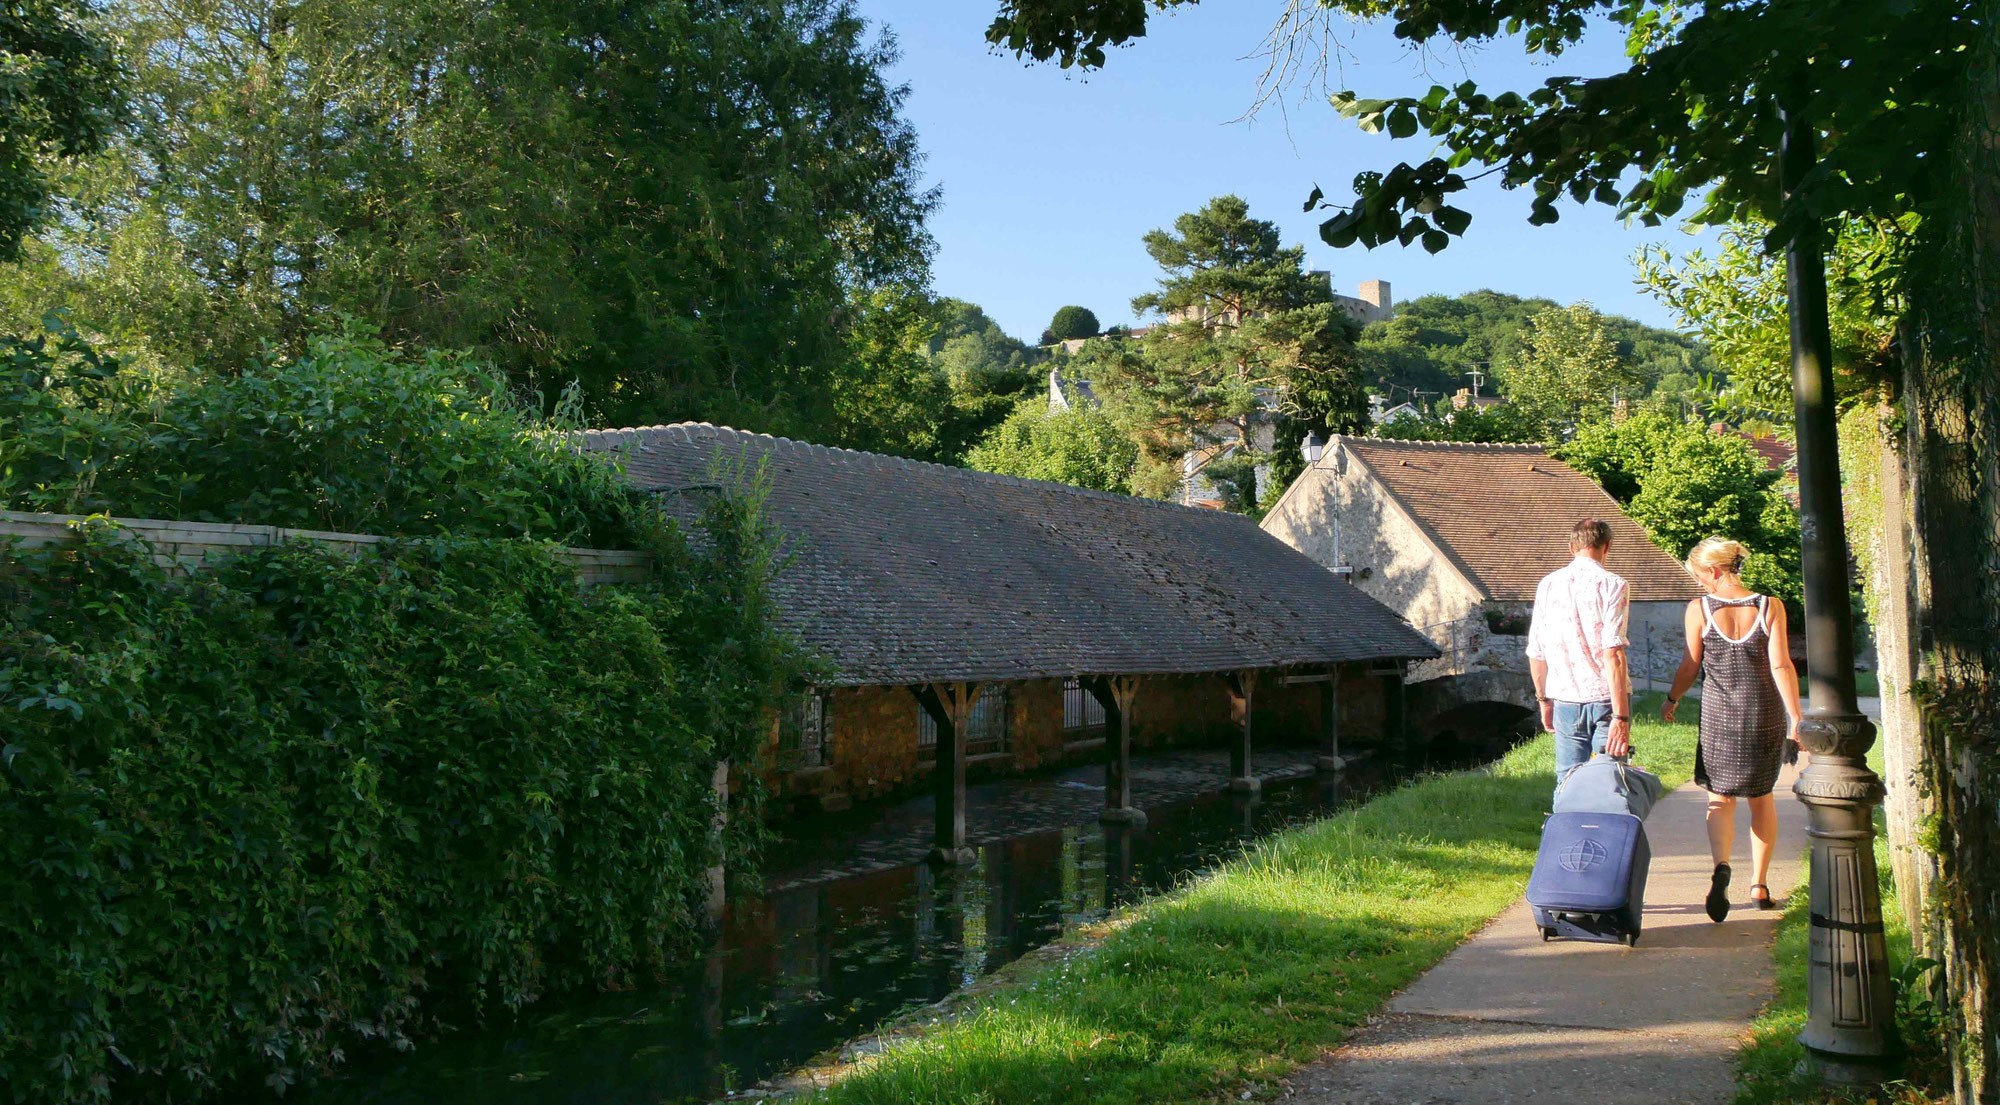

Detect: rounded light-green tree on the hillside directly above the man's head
1502,302,1636,442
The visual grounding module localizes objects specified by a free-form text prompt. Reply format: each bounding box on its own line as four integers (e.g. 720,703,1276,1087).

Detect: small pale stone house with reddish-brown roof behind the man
1262,436,1696,689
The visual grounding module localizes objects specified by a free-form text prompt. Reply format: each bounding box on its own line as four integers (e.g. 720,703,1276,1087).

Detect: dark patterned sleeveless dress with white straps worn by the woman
1694,595,1792,799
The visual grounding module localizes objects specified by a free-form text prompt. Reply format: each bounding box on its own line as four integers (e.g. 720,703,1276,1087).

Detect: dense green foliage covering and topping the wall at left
0,324,792,1103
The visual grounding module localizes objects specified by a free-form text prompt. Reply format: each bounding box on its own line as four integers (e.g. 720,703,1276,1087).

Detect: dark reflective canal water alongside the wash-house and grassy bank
304,740,1484,1105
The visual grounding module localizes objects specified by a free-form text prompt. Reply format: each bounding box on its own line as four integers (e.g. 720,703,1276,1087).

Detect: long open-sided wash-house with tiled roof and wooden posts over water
580,422,1438,861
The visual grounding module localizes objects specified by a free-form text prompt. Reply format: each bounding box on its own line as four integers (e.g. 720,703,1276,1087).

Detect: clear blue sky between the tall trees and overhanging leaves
858,0,1696,340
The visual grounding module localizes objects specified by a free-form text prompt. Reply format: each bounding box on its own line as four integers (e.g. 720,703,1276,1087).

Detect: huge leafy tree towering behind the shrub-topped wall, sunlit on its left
8,0,934,436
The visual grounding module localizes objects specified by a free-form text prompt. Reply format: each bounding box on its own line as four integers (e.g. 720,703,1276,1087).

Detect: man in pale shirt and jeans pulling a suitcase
1528,518,1632,787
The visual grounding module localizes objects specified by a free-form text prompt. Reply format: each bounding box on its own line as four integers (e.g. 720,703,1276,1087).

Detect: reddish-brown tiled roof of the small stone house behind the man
1322,436,1694,603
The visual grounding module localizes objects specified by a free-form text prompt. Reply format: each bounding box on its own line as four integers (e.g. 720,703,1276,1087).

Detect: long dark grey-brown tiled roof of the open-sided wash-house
582,422,1438,685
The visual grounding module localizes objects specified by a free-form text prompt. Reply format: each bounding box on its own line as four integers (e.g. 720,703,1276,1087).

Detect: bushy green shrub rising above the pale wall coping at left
0,316,650,546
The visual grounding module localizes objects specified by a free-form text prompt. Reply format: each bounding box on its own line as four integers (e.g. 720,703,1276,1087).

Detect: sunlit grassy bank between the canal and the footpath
804,697,1694,1105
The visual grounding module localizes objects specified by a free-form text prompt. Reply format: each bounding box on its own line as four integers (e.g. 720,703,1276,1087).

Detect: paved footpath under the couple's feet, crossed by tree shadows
1282,769,1806,1105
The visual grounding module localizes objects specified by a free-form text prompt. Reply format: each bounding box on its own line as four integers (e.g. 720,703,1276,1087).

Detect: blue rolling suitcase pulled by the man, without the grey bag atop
1528,813,1652,945
